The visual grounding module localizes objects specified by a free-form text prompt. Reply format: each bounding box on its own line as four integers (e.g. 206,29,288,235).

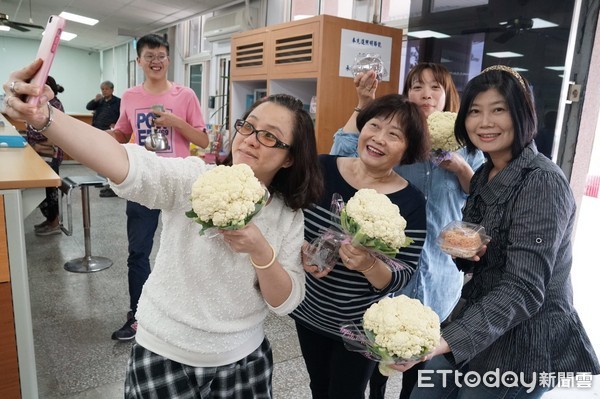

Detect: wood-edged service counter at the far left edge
0,114,61,399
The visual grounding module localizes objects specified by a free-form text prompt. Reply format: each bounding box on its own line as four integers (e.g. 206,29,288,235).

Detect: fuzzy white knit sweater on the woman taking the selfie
112,145,305,367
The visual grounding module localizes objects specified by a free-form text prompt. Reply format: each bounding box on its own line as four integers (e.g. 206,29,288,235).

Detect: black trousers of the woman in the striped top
296,322,377,399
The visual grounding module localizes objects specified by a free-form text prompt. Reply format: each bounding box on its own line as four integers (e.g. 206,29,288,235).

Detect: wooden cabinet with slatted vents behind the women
229,15,402,153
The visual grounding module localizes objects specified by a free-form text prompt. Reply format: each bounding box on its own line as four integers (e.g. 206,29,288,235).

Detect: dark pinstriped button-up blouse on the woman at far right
443,144,600,375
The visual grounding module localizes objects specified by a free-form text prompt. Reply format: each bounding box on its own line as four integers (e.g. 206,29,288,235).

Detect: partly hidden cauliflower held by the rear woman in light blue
427,111,460,165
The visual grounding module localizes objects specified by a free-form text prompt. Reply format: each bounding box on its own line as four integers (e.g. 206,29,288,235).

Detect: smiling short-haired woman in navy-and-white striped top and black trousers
292,94,429,399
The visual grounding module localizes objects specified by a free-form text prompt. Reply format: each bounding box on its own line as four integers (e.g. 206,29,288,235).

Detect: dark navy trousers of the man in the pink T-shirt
125,201,160,314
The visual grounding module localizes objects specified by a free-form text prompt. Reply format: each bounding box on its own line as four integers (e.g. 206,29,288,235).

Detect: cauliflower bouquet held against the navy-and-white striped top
340,188,413,258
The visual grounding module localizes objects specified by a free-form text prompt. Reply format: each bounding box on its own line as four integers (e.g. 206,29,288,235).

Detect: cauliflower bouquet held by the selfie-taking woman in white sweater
185,164,269,235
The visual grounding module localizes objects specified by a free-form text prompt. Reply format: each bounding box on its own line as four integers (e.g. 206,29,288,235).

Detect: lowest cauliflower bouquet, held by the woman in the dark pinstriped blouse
340,295,440,375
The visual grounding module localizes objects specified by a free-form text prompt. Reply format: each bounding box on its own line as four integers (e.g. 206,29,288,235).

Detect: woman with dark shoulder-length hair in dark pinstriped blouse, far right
398,65,600,399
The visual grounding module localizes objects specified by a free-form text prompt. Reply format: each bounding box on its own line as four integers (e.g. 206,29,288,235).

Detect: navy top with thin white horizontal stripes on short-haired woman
291,155,426,340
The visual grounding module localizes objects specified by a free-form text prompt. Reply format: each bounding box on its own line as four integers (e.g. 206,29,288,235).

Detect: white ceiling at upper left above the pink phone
0,0,244,50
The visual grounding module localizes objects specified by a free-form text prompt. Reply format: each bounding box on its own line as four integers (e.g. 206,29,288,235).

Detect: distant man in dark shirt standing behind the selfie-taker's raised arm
85,80,121,197
